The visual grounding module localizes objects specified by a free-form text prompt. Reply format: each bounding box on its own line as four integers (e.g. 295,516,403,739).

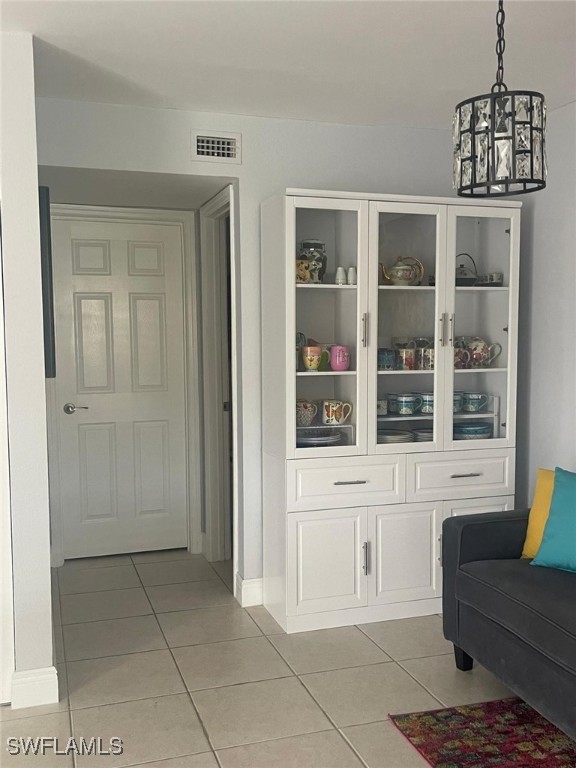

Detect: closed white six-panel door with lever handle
52,217,187,558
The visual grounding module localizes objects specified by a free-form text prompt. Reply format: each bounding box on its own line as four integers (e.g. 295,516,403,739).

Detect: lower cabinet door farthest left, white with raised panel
287,507,367,615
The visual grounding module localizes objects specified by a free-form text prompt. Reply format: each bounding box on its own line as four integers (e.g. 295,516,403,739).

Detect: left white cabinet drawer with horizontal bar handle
286,456,406,512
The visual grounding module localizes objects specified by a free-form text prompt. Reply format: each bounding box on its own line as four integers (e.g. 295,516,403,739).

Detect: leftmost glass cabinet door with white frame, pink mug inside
288,198,368,457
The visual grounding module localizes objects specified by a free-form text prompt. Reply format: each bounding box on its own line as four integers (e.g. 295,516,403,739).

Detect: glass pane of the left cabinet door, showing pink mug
294,208,361,448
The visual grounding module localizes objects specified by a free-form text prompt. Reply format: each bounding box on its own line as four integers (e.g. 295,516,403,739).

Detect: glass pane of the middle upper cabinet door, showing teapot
373,213,437,444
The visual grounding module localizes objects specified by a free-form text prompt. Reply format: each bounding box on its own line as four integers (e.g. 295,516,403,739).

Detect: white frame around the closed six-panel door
46,204,202,567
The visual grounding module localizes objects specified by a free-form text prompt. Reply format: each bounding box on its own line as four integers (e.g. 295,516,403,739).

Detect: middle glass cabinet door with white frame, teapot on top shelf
368,203,446,453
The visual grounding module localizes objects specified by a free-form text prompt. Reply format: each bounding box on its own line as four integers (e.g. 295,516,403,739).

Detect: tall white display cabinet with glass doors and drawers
262,190,520,632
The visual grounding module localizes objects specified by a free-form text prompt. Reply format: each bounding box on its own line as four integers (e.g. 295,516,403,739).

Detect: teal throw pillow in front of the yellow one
531,467,576,572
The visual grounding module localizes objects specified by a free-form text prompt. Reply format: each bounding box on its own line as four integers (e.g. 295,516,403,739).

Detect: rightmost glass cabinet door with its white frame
444,207,519,449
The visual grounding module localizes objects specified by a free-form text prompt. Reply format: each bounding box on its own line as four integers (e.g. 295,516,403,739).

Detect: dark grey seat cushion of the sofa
456,560,576,674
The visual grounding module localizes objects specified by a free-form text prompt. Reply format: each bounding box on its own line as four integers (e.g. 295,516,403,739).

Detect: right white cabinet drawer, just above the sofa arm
406,449,514,501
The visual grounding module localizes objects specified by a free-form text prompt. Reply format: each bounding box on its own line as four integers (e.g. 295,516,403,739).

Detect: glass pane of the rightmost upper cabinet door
452,216,511,441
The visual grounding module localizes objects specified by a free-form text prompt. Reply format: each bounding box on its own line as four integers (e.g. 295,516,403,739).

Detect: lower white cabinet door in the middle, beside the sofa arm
368,501,443,604
